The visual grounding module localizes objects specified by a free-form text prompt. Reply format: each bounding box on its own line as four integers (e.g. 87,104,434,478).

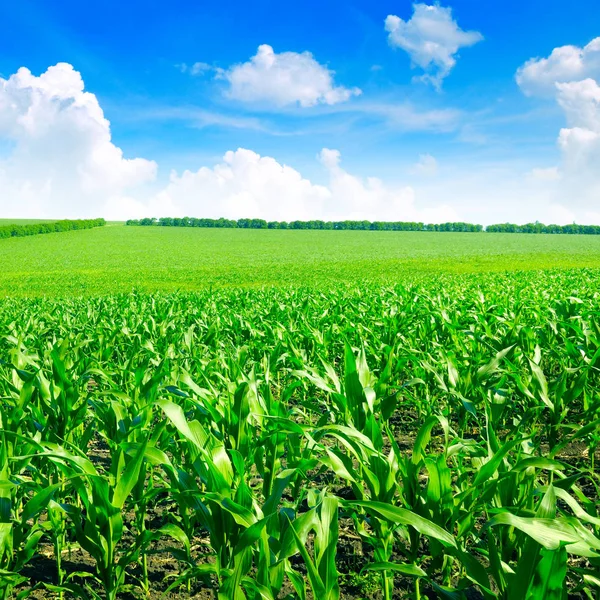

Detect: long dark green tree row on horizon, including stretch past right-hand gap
126,217,600,235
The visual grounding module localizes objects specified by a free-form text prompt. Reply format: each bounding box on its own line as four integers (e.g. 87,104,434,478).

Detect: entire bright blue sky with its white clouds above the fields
0,0,600,222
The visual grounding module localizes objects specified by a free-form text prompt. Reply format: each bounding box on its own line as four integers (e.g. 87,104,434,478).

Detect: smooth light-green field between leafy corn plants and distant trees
0,224,600,296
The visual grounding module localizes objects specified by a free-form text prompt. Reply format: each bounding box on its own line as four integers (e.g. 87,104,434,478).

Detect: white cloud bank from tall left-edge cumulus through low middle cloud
0,59,456,221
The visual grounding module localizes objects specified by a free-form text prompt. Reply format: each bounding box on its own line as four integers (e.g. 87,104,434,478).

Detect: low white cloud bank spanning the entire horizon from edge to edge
0,59,600,224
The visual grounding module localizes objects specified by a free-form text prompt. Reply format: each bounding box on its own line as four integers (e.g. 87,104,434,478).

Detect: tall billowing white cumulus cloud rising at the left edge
0,63,156,217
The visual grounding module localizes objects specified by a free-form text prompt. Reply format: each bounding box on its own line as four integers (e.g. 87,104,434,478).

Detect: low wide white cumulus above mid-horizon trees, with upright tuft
154,148,456,222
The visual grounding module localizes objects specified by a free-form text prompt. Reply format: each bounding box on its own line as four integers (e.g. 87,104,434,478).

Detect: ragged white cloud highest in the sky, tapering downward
385,4,483,88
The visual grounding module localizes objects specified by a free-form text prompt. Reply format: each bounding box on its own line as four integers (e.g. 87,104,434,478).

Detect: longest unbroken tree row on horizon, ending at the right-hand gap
126,217,483,232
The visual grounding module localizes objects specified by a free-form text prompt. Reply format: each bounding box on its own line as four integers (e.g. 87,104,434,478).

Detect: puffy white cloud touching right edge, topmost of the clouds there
516,37,600,96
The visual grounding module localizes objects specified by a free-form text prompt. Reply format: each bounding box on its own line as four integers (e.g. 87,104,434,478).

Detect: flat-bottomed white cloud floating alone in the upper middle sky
219,44,361,107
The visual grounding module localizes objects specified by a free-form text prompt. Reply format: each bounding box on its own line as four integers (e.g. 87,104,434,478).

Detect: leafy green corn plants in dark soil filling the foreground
0,272,600,600
